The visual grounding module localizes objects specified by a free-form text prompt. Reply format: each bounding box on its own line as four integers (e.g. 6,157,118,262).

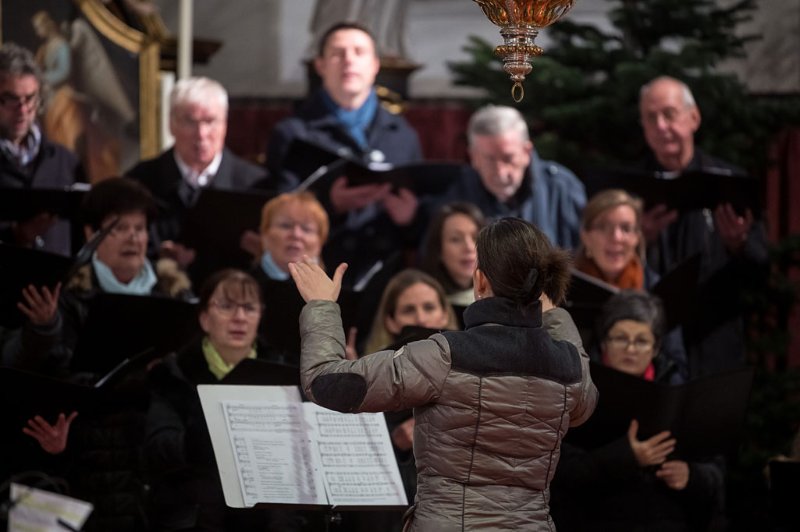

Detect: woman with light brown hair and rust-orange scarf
575,189,688,384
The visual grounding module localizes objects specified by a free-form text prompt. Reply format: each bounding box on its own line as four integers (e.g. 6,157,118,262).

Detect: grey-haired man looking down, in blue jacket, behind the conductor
447,105,586,249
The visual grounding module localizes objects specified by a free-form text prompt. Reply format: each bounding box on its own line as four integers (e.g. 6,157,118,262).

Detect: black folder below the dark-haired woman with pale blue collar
72,293,200,374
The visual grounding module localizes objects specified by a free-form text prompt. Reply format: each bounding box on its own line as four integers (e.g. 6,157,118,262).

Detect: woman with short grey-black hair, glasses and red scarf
551,290,724,532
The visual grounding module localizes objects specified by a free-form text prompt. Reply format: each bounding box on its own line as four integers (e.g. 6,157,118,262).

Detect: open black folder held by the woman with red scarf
566,362,753,460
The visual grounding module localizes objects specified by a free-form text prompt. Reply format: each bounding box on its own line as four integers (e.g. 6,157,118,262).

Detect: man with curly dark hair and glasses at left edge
0,43,83,255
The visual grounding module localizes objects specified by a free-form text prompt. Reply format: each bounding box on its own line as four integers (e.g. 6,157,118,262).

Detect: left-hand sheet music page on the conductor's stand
221,401,328,506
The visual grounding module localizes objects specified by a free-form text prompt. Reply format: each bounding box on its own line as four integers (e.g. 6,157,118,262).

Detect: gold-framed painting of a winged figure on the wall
0,0,159,182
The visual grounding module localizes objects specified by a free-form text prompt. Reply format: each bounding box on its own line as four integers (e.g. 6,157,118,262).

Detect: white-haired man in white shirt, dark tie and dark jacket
126,77,266,278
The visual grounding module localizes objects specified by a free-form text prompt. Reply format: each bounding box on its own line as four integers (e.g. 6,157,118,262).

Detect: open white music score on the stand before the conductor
197,385,408,510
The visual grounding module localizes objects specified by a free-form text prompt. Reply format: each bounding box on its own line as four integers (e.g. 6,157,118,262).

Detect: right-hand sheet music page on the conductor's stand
302,403,408,507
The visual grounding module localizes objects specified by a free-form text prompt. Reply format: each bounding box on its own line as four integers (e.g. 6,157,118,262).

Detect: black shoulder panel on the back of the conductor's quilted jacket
443,325,581,384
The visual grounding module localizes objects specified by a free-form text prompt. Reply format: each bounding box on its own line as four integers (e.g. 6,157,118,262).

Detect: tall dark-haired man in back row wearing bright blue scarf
267,23,422,281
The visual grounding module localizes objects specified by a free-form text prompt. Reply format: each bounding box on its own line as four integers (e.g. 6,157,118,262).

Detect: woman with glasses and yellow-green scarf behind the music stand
143,269,290,531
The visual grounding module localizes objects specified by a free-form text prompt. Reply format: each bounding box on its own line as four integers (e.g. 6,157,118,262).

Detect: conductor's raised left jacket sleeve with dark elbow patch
300,301,450,412
